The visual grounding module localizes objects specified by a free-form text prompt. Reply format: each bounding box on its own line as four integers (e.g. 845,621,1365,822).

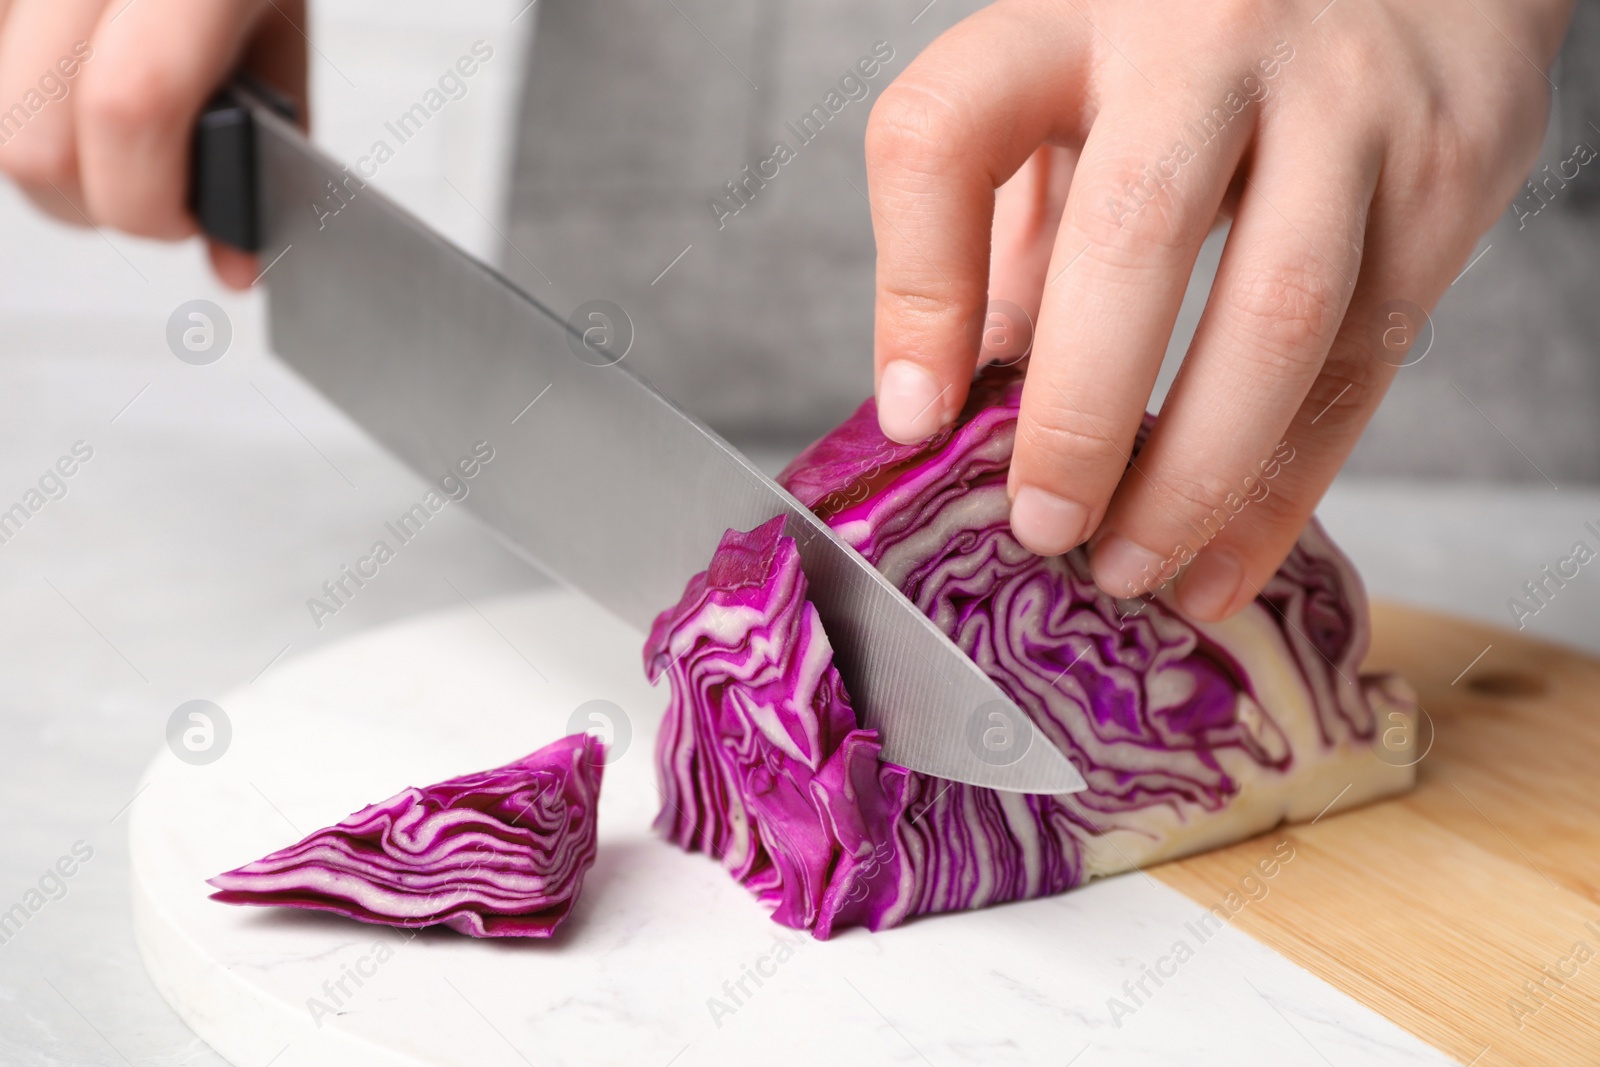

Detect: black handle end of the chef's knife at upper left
189,75,294,251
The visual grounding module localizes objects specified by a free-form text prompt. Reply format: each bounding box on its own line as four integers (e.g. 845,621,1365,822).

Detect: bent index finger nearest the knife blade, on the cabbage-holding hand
867,3,1086,443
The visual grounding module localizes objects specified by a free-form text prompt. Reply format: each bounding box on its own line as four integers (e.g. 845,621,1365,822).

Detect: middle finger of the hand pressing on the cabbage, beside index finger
1008,83,1254,555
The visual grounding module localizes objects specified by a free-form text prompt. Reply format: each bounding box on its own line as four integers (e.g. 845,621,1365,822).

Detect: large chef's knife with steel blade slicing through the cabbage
190,82,1085,793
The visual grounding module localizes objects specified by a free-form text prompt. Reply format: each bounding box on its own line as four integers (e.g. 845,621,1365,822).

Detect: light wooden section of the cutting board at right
1150,605,1600,1067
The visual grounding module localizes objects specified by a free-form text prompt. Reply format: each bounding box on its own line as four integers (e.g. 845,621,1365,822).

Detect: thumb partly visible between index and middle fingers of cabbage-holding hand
986,144,1077,334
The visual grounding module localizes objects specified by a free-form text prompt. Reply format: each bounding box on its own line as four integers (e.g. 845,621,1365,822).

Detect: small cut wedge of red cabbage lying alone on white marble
210,734,605,937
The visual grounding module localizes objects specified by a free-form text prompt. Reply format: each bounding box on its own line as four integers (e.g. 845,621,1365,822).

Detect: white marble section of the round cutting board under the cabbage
130,592,1453,1067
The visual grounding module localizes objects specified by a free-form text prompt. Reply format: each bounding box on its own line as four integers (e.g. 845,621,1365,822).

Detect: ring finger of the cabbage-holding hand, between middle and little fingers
1093,146,1381,607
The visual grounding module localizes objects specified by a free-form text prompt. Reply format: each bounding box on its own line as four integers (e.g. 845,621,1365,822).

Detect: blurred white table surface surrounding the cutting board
0,18,1600,1067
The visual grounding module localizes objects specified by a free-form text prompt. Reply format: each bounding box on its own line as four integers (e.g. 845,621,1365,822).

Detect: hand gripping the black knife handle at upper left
0,0,306,288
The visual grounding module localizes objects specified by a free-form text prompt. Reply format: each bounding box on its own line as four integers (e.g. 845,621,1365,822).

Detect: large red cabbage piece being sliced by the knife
645,371,1414,937
